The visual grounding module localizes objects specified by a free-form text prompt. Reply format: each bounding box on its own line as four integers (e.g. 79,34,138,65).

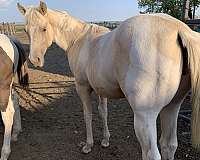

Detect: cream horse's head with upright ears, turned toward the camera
17,1,53,67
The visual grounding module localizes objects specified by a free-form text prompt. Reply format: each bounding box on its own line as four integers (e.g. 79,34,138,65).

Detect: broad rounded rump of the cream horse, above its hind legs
114,16,183,110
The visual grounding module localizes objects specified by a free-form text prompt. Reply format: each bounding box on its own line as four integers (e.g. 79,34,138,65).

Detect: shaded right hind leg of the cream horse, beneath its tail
160,76,190,160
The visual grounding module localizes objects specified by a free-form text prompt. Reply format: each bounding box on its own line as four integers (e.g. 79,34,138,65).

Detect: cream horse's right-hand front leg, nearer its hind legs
98,96,110,147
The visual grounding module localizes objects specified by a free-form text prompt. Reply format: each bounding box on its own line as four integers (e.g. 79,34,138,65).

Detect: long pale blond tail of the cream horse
178,30,200,149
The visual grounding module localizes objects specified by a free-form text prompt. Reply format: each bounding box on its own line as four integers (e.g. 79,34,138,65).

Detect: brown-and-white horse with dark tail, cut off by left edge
0,34,28,160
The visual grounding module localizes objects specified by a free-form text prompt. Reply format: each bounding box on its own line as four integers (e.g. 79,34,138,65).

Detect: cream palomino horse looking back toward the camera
18,2,200,160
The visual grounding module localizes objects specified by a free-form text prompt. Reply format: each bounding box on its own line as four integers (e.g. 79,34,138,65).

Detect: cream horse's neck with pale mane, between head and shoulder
47,11,109,72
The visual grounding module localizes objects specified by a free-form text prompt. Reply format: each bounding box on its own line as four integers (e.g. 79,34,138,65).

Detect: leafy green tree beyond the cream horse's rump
138,0,200,19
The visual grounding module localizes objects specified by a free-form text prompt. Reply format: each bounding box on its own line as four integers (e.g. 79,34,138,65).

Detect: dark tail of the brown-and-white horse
12,38,29,87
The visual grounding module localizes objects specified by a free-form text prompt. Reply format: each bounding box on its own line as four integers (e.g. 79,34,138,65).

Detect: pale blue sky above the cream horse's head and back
0,0,139,22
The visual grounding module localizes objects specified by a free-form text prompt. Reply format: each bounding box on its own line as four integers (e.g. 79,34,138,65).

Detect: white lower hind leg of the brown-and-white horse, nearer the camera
1,92,15,160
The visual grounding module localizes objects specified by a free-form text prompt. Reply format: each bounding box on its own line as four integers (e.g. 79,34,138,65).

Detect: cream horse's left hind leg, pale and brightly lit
126,89,161,160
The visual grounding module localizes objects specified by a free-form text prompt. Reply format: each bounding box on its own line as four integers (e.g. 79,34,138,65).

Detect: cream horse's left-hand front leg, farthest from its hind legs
76,83,94,153
